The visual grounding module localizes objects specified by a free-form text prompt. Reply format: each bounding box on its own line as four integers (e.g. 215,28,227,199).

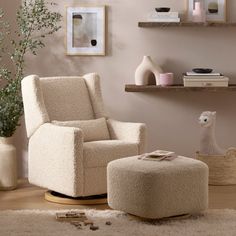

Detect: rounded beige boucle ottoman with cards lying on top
107,156,208,219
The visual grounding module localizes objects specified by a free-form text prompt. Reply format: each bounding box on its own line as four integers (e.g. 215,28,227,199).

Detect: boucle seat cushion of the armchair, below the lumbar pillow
83,140,138,168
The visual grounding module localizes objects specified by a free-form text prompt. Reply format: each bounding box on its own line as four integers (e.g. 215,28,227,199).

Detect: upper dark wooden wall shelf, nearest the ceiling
138,21,236,28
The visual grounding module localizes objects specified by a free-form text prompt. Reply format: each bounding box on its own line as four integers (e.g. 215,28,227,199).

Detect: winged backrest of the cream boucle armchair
22,74,106,137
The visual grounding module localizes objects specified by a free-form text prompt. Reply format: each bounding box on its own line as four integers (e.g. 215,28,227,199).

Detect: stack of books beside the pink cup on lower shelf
183,72,229,87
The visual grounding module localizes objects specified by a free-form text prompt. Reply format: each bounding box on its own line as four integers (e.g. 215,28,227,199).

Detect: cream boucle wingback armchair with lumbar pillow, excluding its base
22,74,146,197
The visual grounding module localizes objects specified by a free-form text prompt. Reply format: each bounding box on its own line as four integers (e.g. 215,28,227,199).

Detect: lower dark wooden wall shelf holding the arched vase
125,84,236,92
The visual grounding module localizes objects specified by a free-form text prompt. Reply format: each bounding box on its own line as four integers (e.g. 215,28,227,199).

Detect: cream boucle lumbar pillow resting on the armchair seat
52,118,110,142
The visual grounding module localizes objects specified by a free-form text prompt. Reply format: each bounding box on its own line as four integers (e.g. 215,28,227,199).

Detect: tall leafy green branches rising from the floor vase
0,0,62,137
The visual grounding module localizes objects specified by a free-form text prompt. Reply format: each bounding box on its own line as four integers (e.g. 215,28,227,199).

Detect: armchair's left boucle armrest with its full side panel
29,123,83,197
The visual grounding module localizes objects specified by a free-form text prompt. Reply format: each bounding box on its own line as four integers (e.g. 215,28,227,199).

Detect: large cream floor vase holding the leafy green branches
0,137,17,190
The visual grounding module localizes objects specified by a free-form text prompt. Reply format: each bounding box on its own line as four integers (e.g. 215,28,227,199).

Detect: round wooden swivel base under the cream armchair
44,190,107,205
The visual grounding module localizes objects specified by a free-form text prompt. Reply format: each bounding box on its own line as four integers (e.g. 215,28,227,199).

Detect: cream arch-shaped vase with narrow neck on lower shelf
135,56,163,85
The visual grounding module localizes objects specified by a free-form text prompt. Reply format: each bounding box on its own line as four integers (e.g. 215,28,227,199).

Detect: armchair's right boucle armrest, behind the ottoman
107,119,147,154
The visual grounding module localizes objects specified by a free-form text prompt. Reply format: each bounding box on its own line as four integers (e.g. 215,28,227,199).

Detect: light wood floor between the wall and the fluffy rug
0,180,236,210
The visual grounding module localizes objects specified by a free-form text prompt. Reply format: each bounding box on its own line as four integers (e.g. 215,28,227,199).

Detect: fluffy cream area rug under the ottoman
0,210,236,236
